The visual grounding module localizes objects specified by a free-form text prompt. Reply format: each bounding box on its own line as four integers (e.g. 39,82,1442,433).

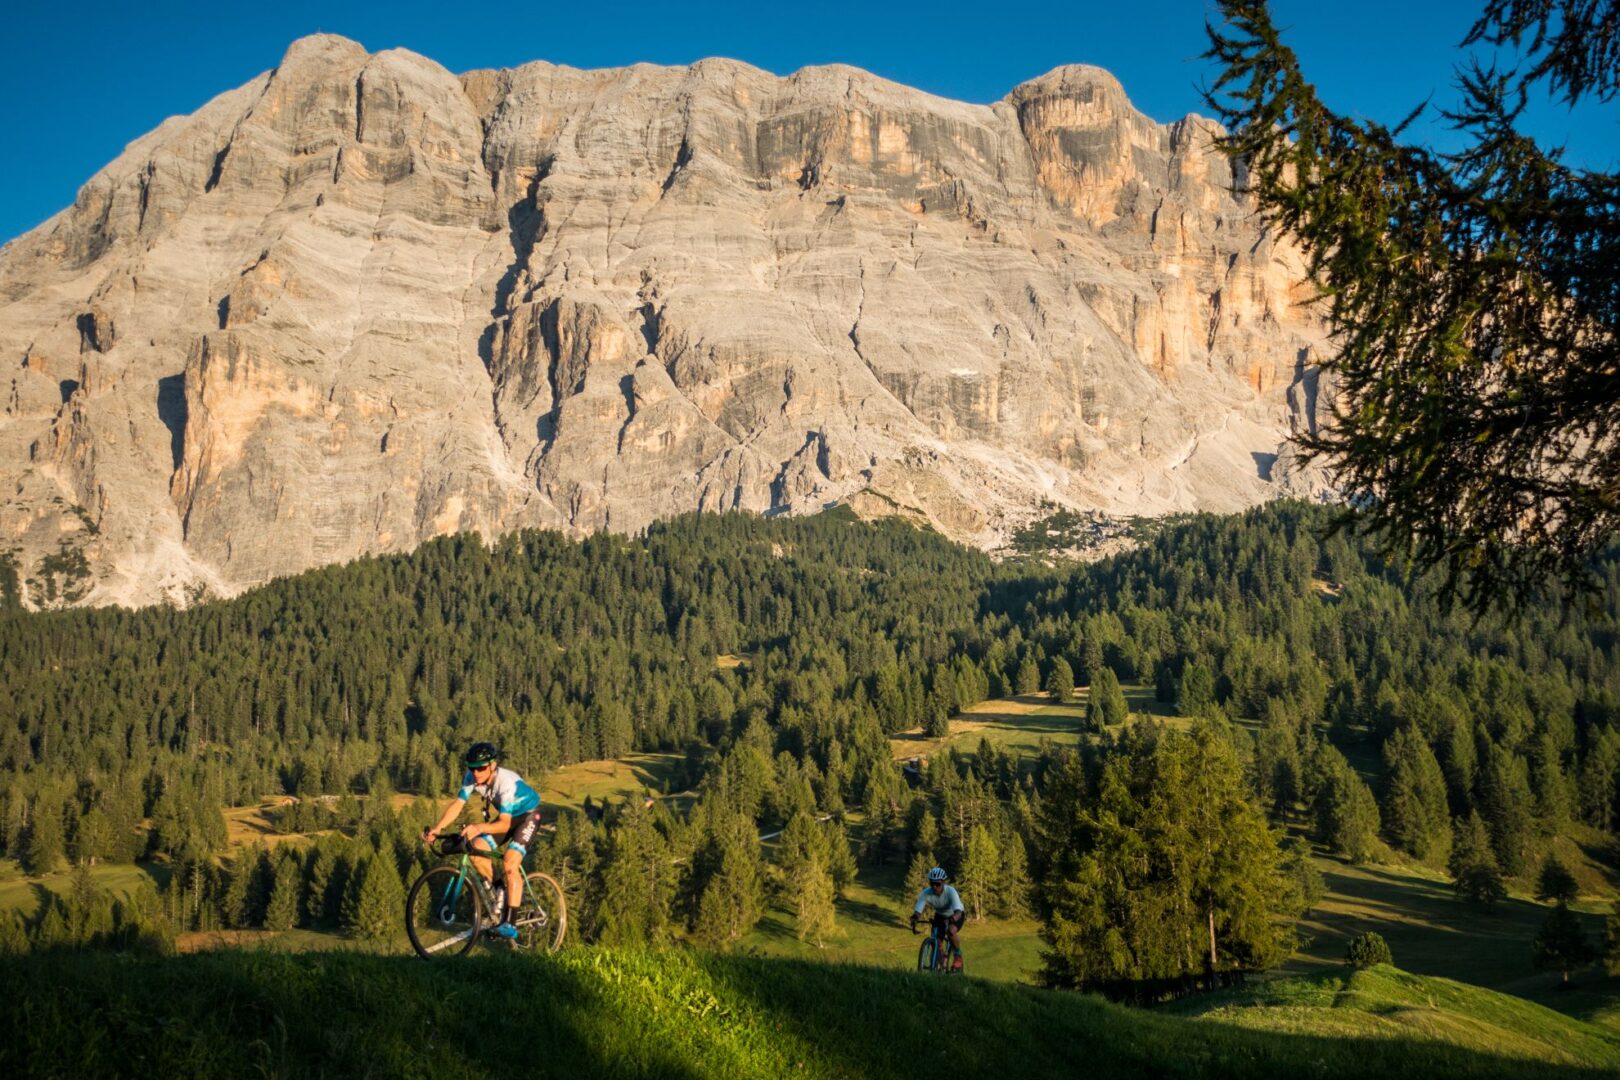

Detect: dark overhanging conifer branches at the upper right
1205,0,1620,608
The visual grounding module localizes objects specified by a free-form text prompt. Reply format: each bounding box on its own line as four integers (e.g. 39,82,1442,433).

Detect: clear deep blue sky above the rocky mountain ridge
0,0,1620,241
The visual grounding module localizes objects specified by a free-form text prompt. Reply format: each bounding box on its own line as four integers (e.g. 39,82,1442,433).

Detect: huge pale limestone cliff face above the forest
0,36,1322,604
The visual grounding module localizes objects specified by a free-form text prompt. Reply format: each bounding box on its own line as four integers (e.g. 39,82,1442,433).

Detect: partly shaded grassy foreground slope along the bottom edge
0,949,1620,1077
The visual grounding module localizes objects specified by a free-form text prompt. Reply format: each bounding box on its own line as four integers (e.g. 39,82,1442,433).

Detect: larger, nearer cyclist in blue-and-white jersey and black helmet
421,743,539,941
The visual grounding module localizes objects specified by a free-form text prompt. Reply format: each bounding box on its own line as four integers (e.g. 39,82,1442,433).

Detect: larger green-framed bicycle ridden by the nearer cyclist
405,834,569,960
